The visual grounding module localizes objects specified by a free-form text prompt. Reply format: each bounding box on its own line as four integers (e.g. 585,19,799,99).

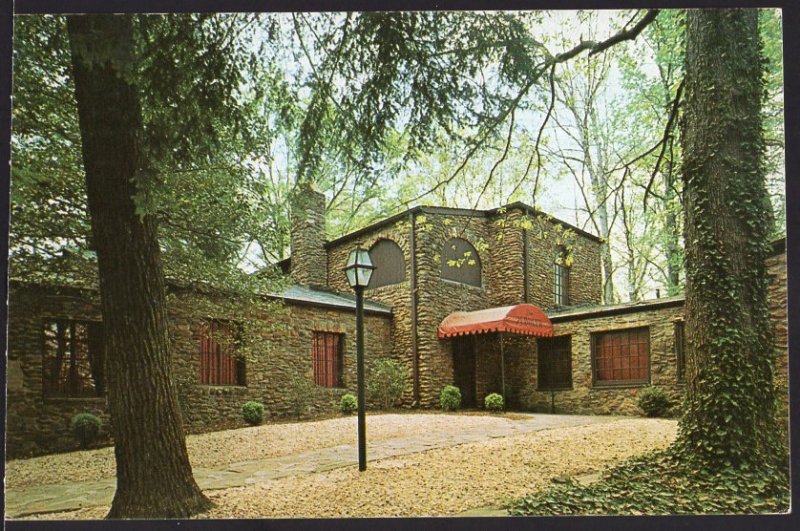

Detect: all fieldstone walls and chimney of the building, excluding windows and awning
7,198,788,457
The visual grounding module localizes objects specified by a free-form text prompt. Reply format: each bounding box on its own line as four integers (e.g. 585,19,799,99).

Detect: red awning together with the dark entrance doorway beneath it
439,304,553,406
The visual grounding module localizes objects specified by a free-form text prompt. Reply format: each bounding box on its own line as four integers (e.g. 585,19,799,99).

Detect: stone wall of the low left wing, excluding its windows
6,286,392,457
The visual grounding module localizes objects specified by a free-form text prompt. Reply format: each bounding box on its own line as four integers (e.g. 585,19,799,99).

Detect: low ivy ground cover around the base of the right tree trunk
509,453,789,516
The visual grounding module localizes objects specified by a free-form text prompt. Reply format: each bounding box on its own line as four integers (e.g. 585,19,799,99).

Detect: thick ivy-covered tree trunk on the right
676,9,779,469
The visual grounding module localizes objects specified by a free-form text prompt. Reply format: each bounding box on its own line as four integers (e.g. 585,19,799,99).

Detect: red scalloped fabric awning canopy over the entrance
439,304,553,339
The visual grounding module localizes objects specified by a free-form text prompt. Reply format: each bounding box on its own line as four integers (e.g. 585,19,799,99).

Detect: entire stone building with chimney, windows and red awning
7,188,787,456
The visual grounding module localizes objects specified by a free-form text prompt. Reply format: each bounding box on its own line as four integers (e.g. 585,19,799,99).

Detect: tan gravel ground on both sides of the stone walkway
8,414,676,519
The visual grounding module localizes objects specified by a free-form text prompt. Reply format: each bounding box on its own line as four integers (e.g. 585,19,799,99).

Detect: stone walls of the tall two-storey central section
326,204,602,407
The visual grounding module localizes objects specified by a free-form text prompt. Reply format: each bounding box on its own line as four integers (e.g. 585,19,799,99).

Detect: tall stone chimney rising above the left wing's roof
289,183,328,288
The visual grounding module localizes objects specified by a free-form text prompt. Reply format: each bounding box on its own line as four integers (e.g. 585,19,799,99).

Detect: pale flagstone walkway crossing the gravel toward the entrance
5,414,619,518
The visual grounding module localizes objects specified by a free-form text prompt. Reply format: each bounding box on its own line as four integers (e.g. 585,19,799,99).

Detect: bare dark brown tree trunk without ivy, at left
67,15,210,518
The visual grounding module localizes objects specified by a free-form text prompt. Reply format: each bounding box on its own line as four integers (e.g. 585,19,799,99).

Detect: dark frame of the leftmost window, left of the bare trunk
41,317,108,401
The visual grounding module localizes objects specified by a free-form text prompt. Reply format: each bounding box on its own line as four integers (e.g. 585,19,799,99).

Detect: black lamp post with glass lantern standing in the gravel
344,245,375,472
